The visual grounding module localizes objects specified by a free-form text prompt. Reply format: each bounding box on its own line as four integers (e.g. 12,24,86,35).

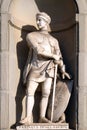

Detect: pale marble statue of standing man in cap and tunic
20,12,70,124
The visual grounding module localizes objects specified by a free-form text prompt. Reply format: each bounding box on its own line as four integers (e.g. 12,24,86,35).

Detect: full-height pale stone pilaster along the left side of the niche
0,1,9,130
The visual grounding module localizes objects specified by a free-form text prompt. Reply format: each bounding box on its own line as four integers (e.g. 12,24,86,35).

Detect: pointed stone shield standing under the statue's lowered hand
47,80,73,122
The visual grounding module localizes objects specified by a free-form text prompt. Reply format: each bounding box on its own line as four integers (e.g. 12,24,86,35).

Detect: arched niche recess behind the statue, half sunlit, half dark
9,0,76,128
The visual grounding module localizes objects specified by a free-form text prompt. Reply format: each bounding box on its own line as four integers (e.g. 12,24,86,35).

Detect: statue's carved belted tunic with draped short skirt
23,32,61,82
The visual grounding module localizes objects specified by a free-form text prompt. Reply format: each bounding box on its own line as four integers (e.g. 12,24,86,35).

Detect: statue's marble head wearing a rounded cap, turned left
36,12,51,29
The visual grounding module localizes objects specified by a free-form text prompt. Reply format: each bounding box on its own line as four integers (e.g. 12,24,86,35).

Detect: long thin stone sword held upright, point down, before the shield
51,64,58,121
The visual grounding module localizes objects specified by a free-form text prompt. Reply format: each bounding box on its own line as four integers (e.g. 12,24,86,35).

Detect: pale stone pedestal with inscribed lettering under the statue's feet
16,123,69,130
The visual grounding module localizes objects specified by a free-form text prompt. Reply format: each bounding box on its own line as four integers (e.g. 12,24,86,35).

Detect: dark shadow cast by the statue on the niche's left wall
11,25,36,129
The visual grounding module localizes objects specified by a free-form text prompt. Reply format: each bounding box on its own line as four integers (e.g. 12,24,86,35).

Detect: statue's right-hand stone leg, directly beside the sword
40,78,52,123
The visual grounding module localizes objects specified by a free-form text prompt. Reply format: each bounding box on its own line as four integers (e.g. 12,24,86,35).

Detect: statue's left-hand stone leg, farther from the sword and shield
20,81,38,125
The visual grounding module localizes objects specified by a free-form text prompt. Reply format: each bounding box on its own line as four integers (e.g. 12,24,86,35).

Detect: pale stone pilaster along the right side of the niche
78,13,87,130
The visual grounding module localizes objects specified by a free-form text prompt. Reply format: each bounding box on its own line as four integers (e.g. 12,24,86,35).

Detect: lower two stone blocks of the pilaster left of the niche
0,47,9,129
